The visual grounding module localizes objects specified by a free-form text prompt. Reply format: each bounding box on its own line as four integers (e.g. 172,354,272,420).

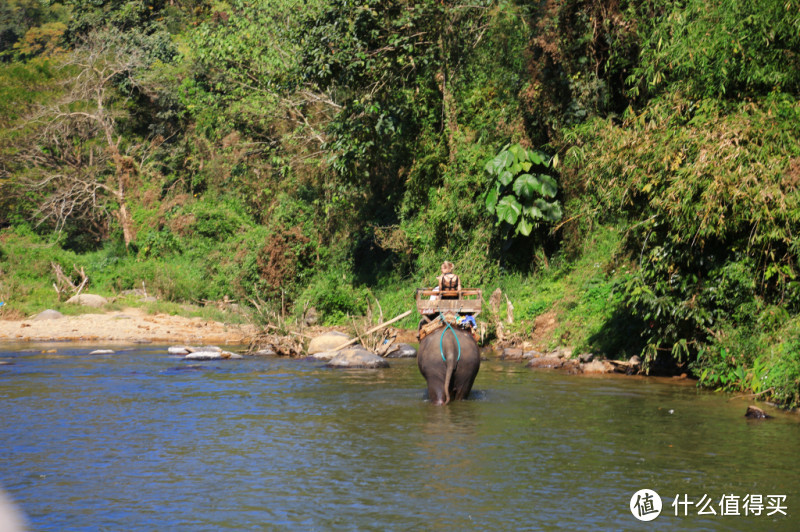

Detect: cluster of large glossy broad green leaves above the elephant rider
483,144,562,236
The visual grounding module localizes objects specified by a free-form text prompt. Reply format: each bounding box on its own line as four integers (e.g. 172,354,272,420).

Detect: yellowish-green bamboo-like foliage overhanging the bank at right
564,90,800,370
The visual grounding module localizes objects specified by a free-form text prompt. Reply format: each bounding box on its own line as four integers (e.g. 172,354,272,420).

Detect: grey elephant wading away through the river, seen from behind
417,327,481,405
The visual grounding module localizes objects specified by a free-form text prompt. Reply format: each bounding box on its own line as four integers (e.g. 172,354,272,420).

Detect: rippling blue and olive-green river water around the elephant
0,345,800,531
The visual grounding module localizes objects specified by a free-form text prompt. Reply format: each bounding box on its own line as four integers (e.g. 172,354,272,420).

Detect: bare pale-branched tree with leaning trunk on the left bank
7,30,170,246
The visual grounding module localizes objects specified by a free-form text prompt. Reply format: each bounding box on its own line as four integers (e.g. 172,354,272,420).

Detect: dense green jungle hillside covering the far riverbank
0,0,800,407
